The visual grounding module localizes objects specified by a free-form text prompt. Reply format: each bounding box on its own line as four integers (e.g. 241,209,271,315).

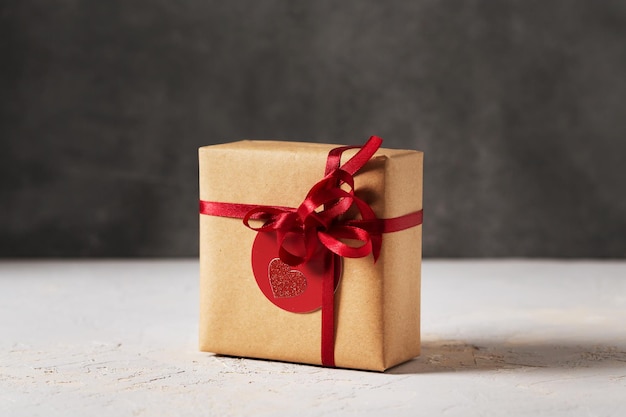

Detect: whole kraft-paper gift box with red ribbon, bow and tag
199,137,423,371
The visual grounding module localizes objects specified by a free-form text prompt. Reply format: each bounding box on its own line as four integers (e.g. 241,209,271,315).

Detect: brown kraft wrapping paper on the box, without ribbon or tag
199,141,423,371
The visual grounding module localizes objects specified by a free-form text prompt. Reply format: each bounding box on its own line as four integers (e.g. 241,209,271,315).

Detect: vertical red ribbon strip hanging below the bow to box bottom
322,252,341,368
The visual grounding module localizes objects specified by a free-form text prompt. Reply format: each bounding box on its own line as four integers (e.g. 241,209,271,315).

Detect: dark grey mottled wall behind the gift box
0,0,626,258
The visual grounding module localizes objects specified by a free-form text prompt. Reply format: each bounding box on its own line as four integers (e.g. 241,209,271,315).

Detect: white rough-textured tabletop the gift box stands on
0,261,626,417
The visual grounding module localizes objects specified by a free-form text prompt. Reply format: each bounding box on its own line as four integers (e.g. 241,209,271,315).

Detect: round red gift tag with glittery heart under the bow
252,232,341,313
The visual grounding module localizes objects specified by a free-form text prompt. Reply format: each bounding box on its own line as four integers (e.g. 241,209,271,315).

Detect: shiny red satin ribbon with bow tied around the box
200,136,423,366
